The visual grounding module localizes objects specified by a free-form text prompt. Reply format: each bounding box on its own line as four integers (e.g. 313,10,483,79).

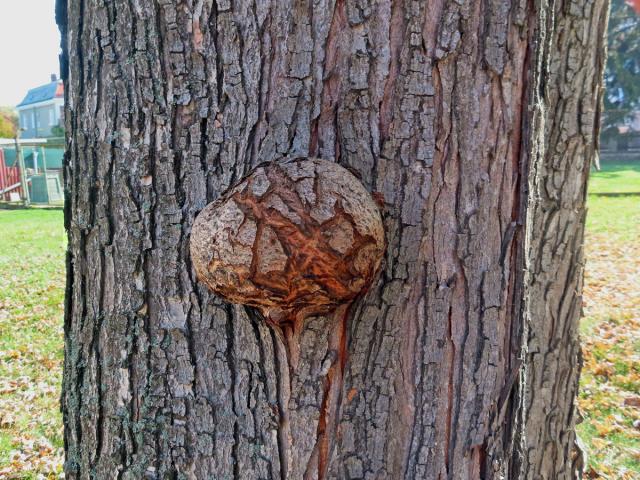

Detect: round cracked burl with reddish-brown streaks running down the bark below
190,158,385,477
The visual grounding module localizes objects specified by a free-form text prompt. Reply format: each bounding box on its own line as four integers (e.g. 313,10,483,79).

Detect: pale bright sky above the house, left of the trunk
0,0,60,106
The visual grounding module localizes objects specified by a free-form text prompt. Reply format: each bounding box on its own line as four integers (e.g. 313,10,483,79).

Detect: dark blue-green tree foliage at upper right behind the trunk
602,0,640,132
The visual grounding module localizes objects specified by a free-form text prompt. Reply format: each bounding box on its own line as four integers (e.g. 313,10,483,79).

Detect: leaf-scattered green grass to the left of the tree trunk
0,209,65,479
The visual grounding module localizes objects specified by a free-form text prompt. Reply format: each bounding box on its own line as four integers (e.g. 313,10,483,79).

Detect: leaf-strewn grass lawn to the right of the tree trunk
578,161,640,480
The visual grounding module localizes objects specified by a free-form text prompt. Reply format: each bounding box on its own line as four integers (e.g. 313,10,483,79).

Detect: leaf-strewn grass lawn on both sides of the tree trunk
0,162,640,480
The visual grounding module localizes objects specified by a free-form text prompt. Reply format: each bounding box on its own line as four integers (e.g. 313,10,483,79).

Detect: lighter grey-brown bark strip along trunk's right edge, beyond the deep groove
522,0,609,479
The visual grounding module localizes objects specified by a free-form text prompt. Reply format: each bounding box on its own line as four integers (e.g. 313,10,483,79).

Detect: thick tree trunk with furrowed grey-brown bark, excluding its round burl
57,0,607,479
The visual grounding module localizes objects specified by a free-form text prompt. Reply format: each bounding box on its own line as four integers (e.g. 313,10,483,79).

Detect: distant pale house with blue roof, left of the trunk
16,75,64,138
